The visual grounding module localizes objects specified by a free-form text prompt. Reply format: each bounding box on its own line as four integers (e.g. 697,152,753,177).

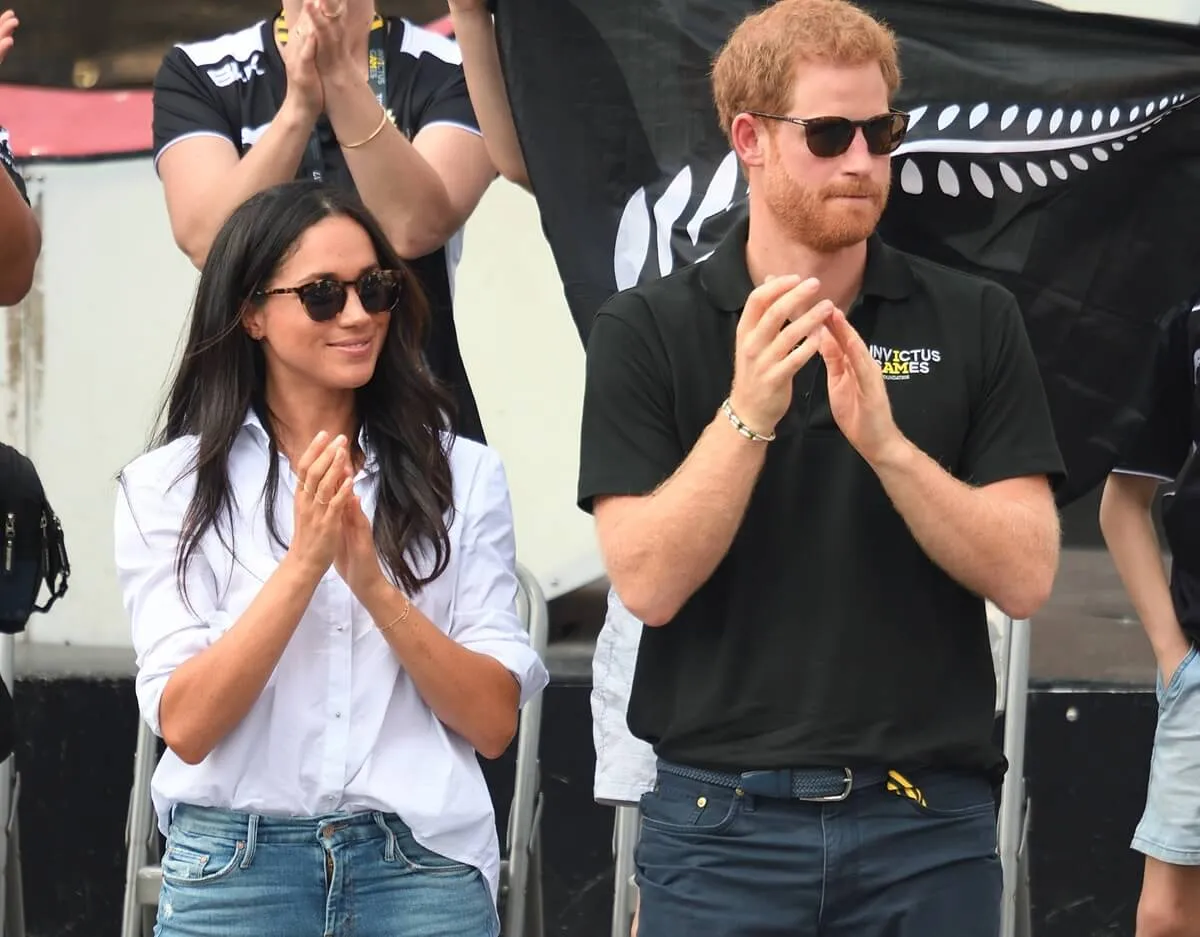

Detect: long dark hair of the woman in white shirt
146,180,454,594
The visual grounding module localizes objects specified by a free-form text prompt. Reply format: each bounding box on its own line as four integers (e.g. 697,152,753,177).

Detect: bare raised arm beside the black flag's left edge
450,7,529,188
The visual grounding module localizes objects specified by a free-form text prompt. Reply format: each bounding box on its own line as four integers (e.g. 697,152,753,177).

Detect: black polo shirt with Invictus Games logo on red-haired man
578,213,1062,770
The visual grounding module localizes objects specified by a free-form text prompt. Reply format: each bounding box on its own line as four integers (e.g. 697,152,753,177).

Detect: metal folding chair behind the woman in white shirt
119,564,550,937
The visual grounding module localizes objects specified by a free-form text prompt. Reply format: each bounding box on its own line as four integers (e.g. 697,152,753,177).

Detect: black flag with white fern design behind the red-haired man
497,0,1200,504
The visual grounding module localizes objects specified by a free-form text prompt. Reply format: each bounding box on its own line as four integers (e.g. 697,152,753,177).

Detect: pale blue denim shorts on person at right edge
1132,647,1200,865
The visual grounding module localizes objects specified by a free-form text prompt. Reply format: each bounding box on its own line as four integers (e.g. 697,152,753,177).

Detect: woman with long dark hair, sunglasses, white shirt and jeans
115,182,546,937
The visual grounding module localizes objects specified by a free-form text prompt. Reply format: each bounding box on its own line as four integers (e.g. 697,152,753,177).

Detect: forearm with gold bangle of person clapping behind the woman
325,76,457,260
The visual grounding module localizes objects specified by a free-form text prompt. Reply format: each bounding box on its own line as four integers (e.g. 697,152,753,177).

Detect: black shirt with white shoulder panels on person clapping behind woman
154,17,484,442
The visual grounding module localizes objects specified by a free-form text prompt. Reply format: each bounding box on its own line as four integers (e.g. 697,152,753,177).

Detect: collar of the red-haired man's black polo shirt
701,214,913,312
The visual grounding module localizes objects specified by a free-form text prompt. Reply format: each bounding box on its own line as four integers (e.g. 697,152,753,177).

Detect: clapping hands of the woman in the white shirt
288,431,383,600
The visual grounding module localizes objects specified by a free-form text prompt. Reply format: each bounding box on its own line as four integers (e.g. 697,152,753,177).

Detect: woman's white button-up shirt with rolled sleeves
115,413,547,897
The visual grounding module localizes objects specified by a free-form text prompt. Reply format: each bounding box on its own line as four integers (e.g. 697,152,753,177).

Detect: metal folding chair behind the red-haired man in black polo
611,607,1033,937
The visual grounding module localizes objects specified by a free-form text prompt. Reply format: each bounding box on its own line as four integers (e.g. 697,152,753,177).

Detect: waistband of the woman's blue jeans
170,804,408,845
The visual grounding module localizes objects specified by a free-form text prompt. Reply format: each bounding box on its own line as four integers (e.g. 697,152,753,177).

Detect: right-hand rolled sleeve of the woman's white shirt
450,450,550,705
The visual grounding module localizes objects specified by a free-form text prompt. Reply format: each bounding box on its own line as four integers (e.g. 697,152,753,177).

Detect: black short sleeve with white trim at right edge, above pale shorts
1115,302,1194,481
